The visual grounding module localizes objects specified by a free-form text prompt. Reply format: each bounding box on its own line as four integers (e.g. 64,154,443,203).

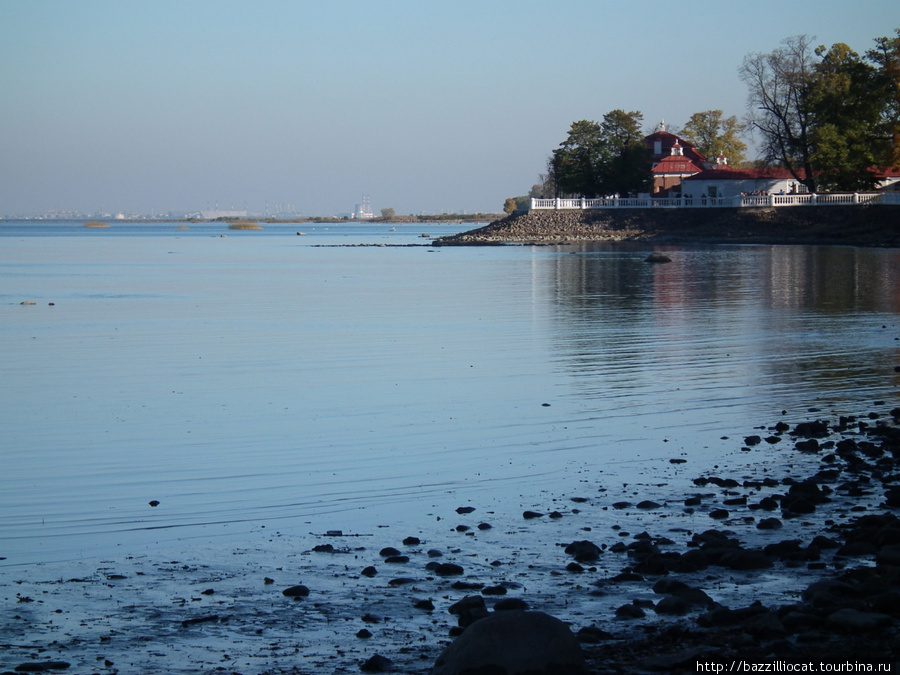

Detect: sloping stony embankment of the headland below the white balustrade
434,204,900,248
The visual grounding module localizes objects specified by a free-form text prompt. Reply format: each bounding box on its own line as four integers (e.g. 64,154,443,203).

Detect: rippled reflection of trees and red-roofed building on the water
551,245,900,411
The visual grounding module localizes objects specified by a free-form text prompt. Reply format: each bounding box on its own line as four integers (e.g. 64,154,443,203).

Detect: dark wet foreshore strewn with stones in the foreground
0,401,900,675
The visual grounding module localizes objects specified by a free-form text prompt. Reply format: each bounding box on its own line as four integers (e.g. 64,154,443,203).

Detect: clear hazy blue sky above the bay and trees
0,0,900,215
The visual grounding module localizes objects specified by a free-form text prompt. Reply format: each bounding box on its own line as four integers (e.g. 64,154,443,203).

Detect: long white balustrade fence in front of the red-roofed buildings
531,192,900,211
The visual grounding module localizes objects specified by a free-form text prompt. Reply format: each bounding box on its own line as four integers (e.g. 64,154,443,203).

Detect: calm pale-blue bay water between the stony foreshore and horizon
0,223,900,565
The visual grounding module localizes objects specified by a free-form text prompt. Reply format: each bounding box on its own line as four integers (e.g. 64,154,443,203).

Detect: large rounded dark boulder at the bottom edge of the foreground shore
431,610,587,675
